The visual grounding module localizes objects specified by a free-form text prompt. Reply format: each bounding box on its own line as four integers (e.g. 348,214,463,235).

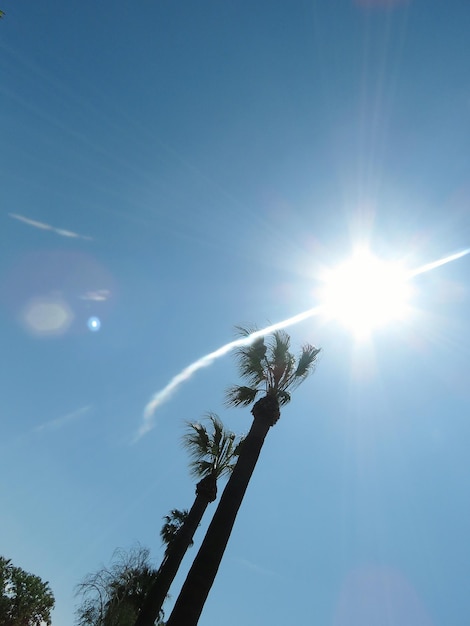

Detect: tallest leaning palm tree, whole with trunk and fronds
167,328,320,626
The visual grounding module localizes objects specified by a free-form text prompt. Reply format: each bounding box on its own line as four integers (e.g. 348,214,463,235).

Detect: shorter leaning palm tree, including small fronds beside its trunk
135,413,241,626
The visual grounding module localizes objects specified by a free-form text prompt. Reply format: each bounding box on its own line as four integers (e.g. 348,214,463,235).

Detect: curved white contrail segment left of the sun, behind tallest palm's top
134,306,321,442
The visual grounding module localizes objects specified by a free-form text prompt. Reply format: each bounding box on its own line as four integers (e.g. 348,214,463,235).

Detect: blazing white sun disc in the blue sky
319,250,411,339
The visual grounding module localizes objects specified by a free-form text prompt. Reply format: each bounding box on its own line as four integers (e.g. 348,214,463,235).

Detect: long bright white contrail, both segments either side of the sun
134,248,470,443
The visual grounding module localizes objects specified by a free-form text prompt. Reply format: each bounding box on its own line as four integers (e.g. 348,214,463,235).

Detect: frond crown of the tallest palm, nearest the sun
227,327,320,406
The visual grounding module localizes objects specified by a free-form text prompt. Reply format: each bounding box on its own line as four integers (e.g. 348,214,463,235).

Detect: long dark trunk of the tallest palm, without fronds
166,396,279,626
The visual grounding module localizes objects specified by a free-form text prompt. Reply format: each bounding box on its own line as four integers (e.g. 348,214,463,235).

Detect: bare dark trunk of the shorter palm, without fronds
135,476,217,626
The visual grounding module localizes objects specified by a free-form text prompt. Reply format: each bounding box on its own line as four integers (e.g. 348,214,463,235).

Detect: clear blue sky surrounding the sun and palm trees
0,0,470,626
